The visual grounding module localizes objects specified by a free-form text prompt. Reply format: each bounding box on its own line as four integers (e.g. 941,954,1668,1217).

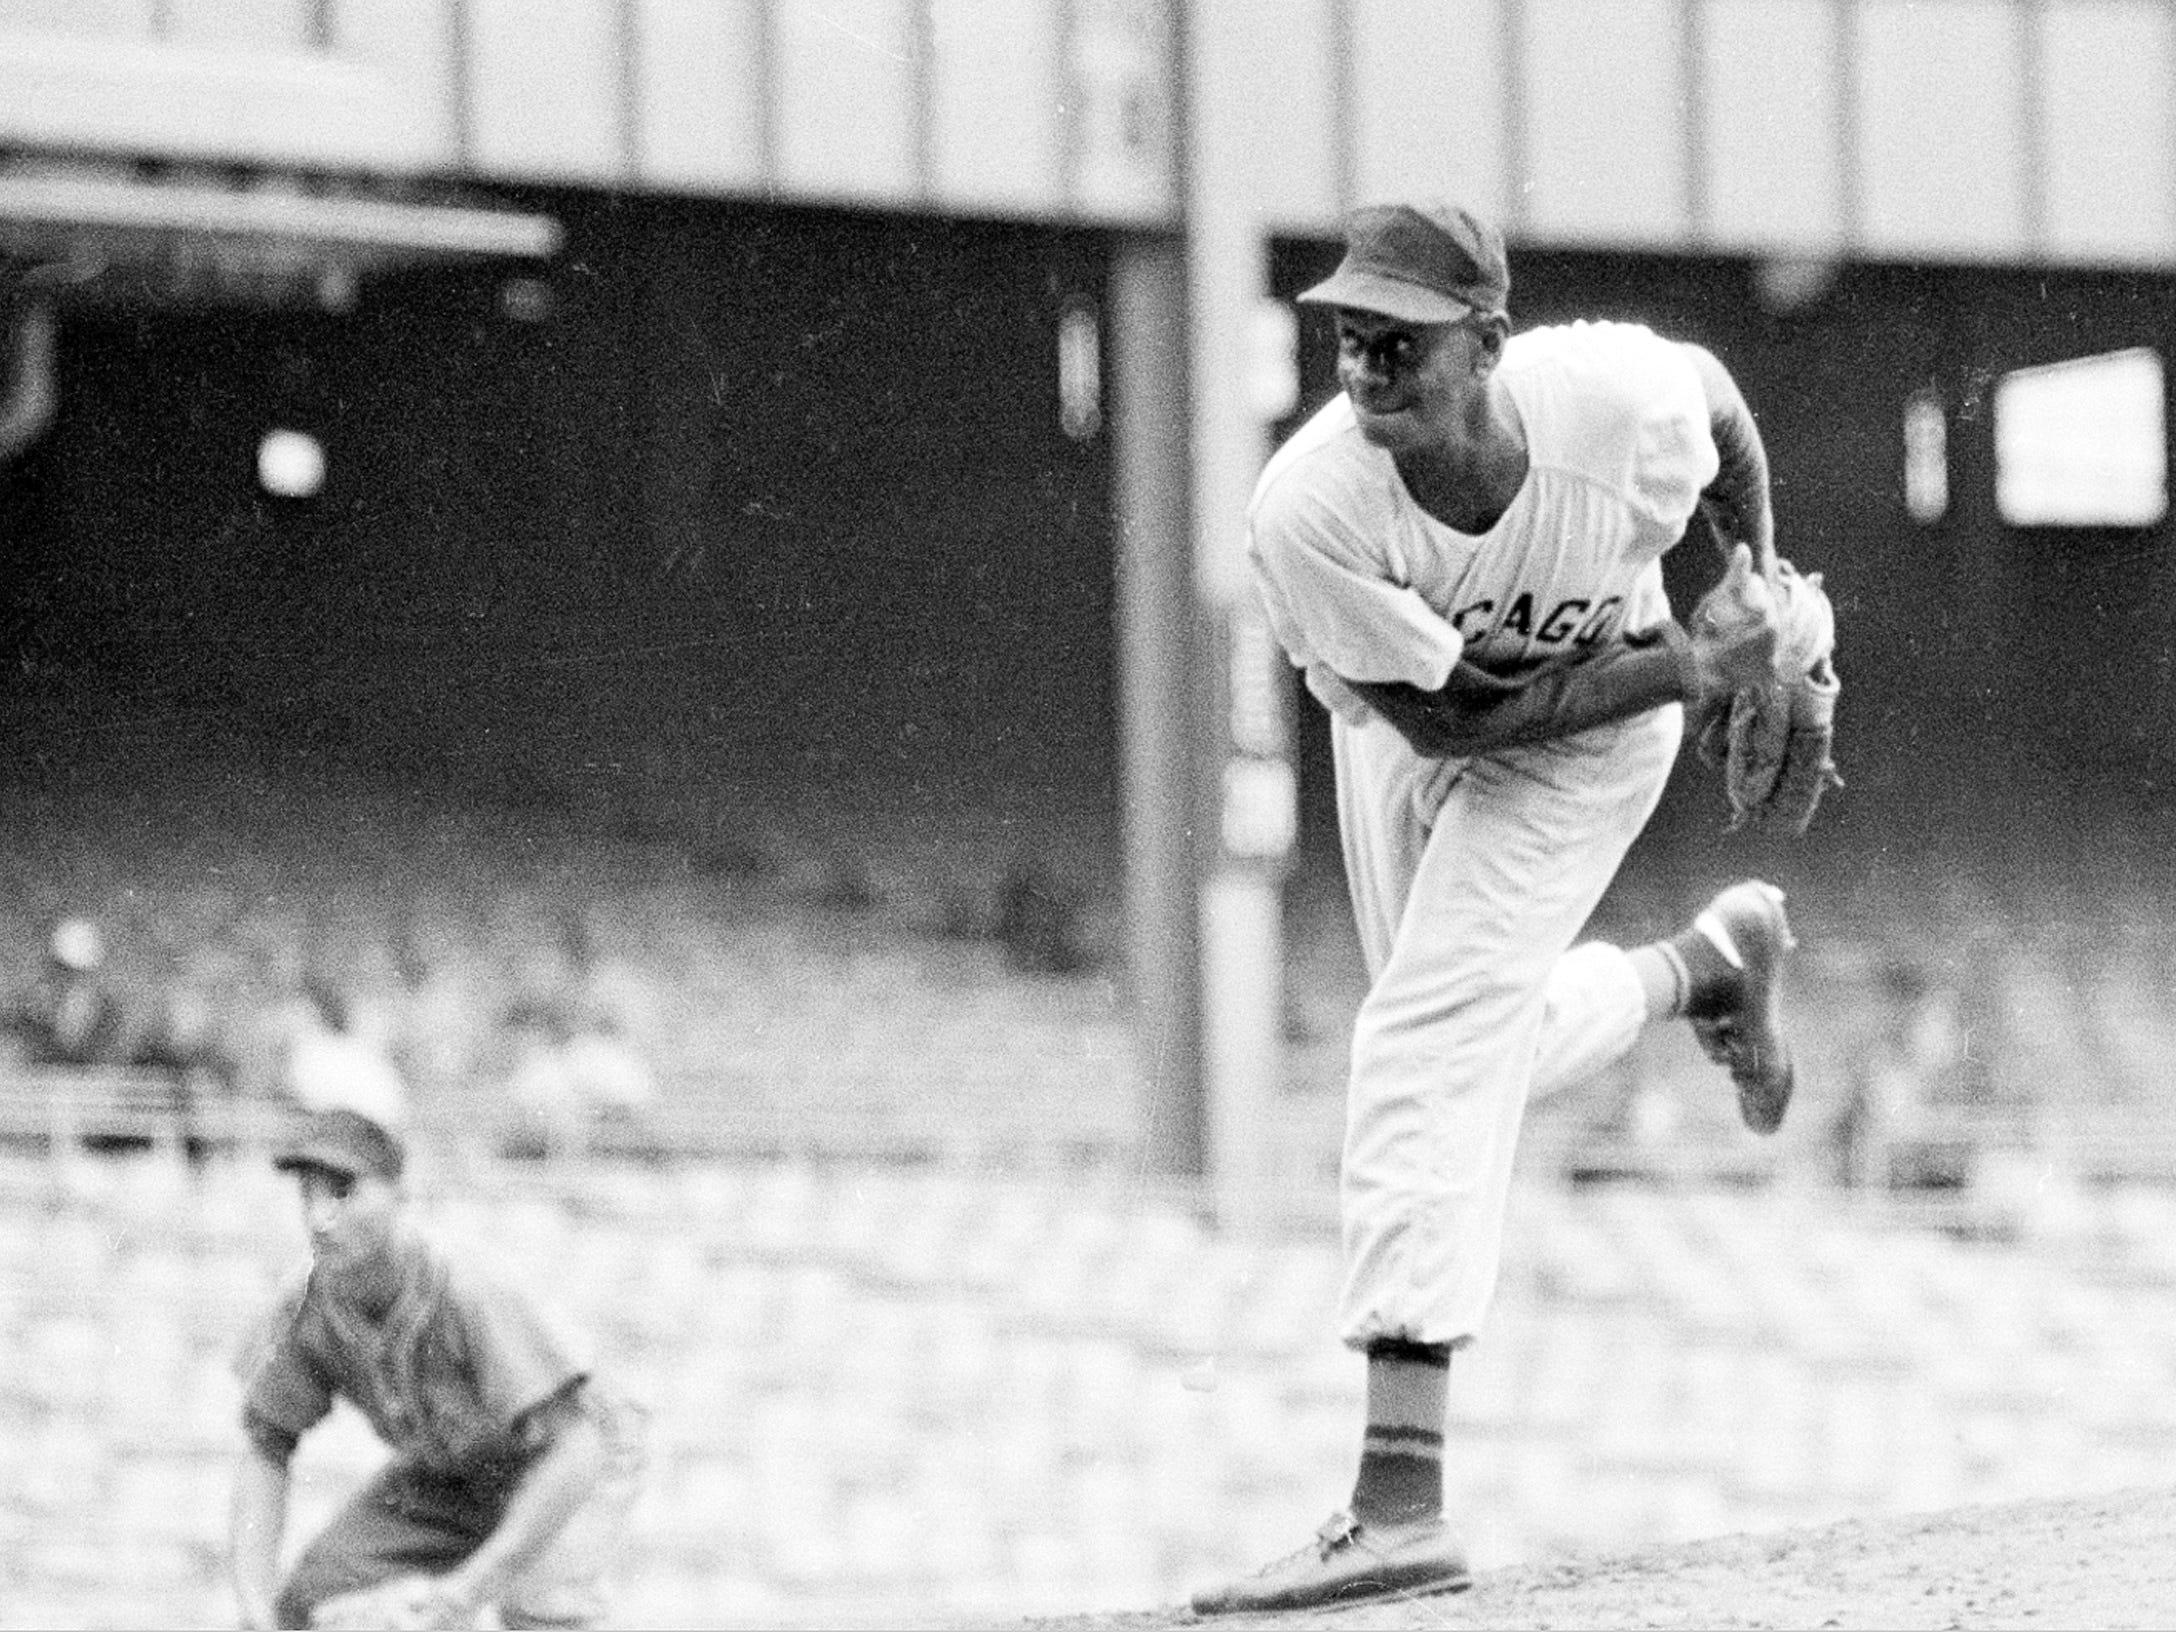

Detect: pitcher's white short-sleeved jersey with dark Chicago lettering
1247,322,1719,720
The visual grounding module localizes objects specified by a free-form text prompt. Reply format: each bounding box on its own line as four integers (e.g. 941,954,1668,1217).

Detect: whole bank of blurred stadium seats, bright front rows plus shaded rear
0,775,2176,1625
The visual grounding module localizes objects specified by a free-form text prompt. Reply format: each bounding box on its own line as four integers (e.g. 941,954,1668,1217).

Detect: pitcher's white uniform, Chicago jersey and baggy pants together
1247,322,1717,1347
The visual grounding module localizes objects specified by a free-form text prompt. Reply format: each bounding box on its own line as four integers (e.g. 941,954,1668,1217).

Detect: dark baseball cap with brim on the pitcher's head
1299,205,1510,322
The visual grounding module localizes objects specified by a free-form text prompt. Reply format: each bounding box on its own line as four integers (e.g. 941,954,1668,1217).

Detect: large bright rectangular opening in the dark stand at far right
1995,346,2169,527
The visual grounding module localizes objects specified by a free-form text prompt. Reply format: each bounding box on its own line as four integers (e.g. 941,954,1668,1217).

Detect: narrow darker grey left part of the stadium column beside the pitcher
1108,233,1208,1177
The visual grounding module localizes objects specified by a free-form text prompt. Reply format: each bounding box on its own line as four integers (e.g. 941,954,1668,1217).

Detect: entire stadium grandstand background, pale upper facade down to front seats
0,0,2176,1628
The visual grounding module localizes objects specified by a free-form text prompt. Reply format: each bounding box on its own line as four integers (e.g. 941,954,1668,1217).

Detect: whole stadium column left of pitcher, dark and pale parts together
1110,0,1297,1229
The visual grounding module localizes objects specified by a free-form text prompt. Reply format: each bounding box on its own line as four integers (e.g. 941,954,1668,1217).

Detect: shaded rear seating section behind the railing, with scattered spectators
0,768,2176,1188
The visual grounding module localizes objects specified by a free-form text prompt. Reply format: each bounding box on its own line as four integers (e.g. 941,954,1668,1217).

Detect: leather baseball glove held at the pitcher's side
1695,559,1843,838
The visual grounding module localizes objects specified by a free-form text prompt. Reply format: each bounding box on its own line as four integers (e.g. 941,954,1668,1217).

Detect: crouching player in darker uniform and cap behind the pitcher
228,1110,642,1628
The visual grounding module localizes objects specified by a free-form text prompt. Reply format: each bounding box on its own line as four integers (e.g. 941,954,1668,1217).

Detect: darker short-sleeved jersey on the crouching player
239,1234,609,1480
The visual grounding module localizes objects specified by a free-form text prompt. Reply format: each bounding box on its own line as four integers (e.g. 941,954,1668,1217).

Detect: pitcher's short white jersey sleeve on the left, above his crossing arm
1247,474,1464,707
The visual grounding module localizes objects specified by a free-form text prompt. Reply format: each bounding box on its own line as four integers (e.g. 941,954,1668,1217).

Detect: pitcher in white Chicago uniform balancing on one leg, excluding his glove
1195,205,1826,1615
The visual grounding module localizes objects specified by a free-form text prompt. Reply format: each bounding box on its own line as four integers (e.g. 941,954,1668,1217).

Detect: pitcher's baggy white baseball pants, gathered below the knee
1332,705,1684,1347
